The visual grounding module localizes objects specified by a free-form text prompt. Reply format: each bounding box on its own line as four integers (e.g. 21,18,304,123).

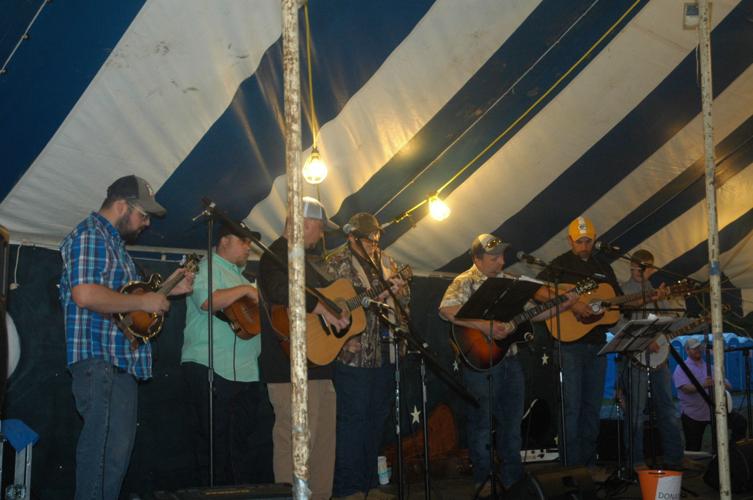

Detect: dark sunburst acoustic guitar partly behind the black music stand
450,279,598,371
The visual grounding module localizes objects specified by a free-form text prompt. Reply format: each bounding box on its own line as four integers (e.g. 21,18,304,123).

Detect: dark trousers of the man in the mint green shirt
181,363,274,486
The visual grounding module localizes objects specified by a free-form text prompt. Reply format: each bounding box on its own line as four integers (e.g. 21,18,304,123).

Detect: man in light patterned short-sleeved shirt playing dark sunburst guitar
439,234,578,498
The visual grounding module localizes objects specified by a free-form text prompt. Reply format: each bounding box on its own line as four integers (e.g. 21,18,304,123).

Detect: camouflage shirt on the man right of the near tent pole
326,244,410,368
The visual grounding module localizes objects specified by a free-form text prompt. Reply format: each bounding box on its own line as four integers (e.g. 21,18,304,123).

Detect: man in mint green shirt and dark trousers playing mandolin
181,225,274,485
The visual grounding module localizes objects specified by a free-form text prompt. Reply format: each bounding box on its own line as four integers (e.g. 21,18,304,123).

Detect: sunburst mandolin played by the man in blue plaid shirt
113,254,200,350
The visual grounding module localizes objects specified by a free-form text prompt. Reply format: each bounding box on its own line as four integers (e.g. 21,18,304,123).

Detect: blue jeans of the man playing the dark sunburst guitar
463,356,525,487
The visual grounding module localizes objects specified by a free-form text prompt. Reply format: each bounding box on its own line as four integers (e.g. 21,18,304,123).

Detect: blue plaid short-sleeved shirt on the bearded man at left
60,212,152,379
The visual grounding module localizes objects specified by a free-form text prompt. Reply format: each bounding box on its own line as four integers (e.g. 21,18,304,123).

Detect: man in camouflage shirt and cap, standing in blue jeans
327,212,410,500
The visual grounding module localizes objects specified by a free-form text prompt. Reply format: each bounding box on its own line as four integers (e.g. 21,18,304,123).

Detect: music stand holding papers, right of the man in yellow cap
598,317,676,478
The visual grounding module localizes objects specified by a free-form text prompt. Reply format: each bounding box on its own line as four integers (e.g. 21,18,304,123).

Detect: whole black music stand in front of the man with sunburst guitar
455,278,541,499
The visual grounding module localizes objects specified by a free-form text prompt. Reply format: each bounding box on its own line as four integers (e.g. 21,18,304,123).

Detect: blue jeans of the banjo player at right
620,364,684,465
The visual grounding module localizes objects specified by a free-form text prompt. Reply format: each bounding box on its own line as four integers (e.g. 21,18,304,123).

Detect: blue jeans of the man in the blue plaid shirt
70,359,138,500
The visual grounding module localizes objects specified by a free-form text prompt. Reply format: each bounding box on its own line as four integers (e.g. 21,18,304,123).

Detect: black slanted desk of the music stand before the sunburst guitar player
455,278,541,321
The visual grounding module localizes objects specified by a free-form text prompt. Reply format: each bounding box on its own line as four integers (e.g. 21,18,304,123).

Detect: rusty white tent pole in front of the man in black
282,0,311,499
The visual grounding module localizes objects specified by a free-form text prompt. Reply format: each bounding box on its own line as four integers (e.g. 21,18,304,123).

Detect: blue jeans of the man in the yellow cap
560,342,607,465
